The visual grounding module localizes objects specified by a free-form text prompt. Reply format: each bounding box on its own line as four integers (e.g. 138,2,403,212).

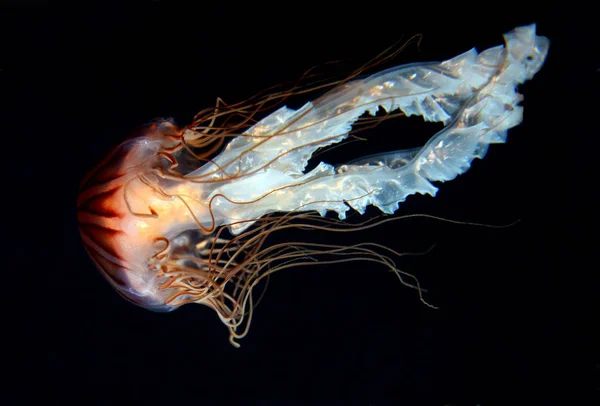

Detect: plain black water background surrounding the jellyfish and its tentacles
0,1,600,405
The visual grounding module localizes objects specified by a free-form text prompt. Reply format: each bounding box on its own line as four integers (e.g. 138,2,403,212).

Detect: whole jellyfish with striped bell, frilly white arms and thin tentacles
77,25,549,346
